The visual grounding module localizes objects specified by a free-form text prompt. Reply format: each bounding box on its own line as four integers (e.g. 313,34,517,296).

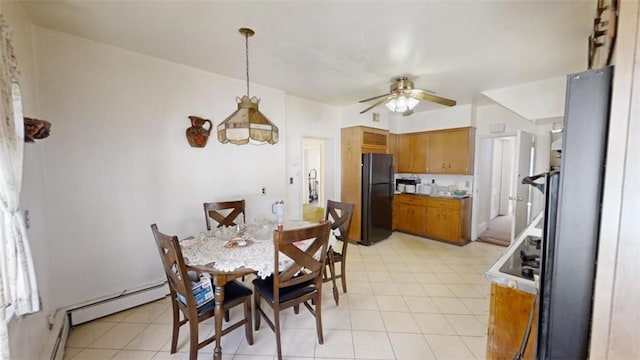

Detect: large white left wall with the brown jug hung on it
35,28,287,306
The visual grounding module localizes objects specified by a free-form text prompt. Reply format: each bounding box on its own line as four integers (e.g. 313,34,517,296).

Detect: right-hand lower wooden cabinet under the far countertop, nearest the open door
425,197,471,245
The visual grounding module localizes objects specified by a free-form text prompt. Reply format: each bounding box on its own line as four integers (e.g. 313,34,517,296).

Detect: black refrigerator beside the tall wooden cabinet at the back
360,153,395,245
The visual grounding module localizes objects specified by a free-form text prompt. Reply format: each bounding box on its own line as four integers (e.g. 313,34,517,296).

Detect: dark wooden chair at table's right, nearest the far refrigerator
323,200,355,305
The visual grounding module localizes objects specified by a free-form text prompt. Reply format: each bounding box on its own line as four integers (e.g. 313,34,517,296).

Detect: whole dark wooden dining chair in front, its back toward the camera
253,223,330,360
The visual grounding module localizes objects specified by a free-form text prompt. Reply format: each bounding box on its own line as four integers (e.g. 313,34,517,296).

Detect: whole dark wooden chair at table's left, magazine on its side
151,224,253,360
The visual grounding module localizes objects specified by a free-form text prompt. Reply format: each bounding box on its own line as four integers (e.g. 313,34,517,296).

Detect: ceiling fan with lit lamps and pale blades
359,76,456,116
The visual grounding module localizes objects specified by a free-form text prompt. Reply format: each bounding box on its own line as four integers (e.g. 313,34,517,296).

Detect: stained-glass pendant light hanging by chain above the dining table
218,28,278,145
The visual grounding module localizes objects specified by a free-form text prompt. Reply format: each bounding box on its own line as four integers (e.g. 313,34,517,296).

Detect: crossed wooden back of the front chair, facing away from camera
273,223,331,293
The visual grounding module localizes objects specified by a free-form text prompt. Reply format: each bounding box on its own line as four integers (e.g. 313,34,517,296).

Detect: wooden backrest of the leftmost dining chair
151,224,196,308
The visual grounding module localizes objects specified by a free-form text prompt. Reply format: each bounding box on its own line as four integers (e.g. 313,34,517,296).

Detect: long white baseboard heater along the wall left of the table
67,281,169,326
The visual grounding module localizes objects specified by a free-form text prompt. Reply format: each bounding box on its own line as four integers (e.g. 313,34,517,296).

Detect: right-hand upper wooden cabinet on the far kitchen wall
424,127,475,175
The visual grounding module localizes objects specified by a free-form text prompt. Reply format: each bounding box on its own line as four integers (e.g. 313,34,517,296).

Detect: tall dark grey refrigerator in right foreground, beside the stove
537,67,613,359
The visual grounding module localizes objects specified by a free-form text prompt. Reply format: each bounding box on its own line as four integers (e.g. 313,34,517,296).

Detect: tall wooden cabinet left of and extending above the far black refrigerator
340,126,389,241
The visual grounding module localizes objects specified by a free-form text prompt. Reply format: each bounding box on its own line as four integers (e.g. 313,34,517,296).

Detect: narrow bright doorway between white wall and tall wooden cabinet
301,138,326,222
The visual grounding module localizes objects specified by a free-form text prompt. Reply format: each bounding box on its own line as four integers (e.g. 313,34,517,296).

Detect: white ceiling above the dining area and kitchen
16,0,596,116
